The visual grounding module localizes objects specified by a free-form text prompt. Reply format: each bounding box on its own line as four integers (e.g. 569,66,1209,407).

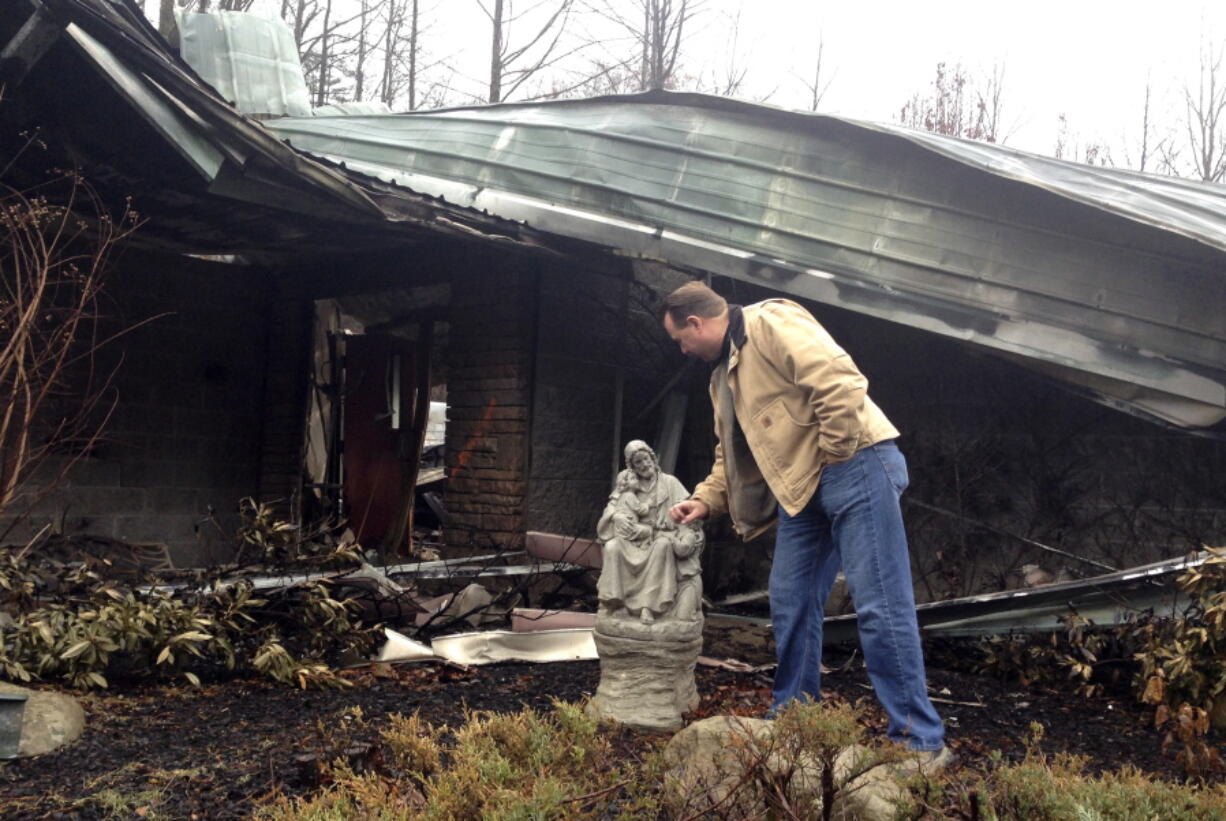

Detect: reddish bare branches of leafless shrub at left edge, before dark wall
0,165,136,538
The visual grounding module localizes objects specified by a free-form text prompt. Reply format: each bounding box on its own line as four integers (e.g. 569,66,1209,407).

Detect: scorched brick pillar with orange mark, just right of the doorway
444,266,537,549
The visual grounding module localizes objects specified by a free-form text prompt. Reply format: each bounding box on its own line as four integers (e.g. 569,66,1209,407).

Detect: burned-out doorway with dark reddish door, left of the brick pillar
303,287,449,564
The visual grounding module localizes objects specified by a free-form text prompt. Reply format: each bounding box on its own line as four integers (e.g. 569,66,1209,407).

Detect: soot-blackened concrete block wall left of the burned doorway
3,254,270,566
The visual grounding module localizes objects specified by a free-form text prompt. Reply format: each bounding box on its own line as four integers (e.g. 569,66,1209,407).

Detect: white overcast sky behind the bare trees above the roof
236,0,1226,164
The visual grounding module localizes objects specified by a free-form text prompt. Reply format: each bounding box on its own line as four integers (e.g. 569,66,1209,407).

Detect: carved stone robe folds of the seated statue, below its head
596,473,698,614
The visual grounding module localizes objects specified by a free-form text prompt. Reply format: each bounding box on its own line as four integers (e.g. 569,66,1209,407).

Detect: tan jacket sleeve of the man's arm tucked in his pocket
758,303,868,462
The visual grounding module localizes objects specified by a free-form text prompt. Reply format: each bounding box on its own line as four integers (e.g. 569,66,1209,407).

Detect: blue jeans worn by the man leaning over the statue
770,441,945,750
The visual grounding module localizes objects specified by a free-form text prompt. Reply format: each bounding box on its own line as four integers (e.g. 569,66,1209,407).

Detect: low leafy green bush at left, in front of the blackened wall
0,500,378,689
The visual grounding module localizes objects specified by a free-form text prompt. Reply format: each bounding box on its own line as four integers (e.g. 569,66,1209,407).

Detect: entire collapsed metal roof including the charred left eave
7,0,1226,436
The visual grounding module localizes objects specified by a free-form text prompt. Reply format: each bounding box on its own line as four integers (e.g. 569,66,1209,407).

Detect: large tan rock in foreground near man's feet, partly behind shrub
664,716,905,821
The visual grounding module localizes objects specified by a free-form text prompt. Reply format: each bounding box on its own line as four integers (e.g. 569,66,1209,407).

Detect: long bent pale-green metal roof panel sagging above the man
267,93,1226,426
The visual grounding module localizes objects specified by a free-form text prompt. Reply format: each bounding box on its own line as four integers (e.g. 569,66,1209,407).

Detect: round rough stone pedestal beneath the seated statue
587,615,702,730
